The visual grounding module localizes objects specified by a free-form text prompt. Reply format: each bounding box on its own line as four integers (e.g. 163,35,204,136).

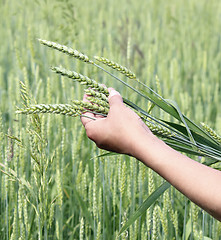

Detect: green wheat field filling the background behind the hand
0,0,221,240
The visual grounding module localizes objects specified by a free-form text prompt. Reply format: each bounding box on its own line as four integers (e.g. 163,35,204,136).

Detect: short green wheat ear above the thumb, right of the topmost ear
94,56,139,81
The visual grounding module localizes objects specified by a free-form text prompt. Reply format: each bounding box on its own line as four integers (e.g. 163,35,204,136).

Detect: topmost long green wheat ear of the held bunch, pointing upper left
38,39,93,64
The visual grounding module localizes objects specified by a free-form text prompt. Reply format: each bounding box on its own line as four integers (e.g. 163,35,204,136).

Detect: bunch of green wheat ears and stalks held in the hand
17,39,221,165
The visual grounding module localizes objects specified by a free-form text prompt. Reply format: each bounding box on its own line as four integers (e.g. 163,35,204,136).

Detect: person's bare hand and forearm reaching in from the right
81,88,221,221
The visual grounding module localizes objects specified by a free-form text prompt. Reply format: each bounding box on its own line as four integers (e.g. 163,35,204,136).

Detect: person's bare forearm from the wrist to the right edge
133,133,221,221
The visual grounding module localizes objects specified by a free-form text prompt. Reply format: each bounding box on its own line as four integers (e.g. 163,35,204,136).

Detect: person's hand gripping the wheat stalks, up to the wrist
81,88,153,157
